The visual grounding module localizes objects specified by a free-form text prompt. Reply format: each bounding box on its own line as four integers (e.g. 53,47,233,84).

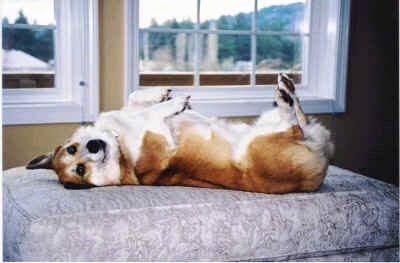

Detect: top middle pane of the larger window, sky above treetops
200,0,254,30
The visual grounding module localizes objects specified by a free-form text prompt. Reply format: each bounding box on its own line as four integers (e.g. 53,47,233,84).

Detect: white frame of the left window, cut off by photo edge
2,0,99,125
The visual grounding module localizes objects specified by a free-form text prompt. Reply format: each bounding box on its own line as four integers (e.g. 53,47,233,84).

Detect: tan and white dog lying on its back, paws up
27,74,333,193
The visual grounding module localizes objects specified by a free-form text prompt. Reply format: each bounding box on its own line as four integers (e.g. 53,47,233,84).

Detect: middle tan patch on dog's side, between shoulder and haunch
157,127,242,188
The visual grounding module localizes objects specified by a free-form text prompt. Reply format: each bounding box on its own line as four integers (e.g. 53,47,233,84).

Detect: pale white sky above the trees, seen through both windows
2,0,305,28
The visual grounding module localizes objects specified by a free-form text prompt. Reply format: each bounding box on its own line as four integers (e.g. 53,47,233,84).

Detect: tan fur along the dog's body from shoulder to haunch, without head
131,123,328,193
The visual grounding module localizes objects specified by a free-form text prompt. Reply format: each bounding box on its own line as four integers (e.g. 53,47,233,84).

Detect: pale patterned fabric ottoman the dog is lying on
3,166,399,261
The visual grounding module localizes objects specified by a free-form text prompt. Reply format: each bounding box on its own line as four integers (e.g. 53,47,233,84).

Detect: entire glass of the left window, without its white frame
2,0,56,89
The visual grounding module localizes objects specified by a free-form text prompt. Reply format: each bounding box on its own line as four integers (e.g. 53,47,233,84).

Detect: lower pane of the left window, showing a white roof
3,25,55,88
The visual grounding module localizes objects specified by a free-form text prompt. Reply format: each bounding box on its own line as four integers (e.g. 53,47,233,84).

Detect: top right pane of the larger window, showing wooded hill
257,0,308,32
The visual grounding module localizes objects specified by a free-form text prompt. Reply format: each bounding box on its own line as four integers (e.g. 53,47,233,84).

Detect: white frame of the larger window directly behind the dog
125,0,350,117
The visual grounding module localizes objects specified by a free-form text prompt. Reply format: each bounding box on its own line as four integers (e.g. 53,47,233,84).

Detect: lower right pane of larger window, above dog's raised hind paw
256,36,305,85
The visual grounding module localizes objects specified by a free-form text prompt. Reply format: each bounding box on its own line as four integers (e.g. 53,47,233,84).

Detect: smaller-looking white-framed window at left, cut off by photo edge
2,0,98,124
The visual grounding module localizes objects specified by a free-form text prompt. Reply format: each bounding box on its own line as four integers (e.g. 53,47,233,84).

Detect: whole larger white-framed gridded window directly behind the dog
125,0,349,116
